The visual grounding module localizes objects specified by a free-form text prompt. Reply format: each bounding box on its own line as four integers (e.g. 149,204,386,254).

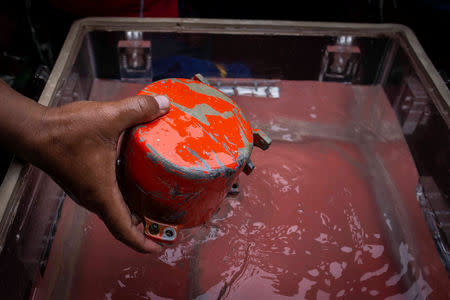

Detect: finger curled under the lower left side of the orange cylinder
99,186,162,252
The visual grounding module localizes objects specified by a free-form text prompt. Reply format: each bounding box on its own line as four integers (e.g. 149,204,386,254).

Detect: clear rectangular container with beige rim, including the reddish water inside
0,18,450,299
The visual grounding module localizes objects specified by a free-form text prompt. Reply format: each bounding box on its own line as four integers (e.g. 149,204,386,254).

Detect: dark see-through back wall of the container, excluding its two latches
85,31,390,84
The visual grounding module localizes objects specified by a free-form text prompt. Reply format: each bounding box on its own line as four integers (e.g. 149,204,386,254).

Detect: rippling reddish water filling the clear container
32,80,449,299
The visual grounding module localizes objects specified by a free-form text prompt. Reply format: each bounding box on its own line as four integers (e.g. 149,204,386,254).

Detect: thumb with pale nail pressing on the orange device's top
113,95,170,132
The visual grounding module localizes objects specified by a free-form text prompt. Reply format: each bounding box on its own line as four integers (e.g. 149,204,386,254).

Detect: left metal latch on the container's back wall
117,31,153,82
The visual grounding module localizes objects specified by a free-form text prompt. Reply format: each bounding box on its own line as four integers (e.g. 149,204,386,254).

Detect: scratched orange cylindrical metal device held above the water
119,75,271,242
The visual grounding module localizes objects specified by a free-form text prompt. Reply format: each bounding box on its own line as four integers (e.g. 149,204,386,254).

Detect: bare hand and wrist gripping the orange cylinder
0,80,169,252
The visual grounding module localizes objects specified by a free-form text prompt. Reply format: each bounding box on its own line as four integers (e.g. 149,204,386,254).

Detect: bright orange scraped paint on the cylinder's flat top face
135,79,252,169
